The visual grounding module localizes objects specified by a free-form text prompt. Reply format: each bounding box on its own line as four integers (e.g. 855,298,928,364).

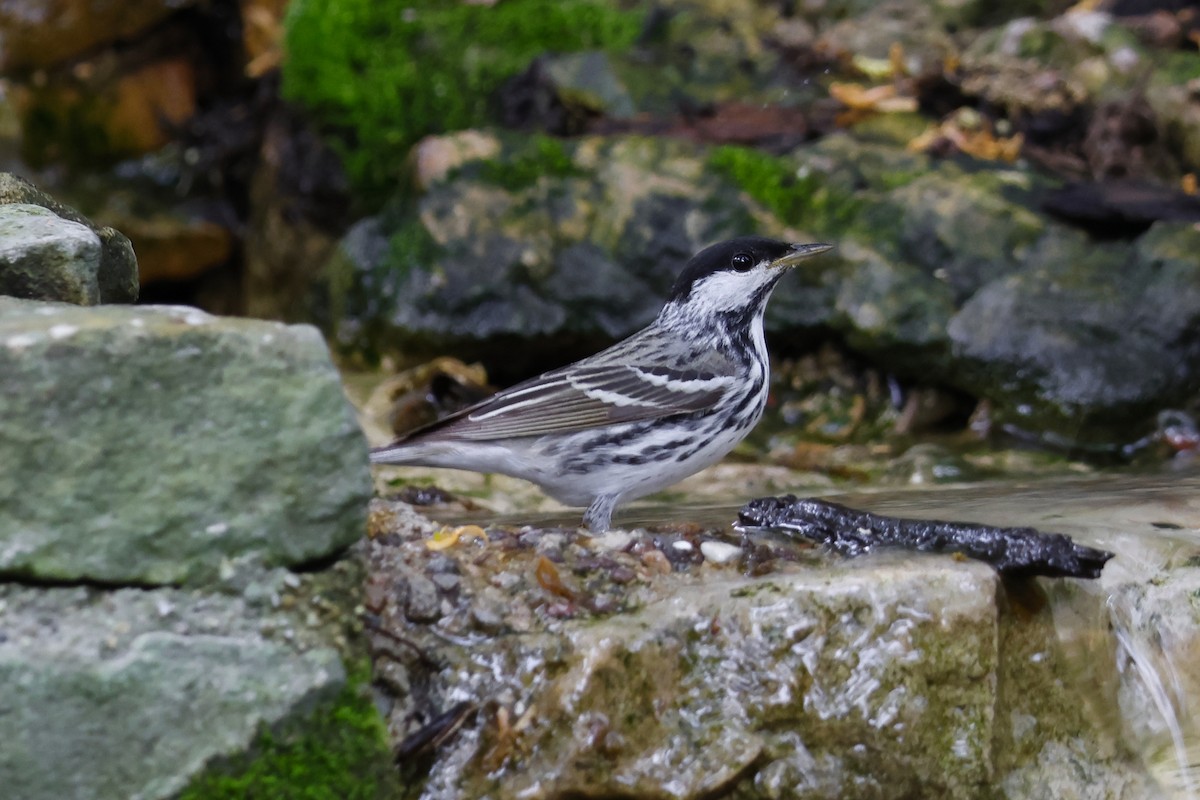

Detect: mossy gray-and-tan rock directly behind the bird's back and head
326,134,806,378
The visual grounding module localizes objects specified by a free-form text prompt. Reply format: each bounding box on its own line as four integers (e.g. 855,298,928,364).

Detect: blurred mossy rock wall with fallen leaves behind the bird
0,0,1200,458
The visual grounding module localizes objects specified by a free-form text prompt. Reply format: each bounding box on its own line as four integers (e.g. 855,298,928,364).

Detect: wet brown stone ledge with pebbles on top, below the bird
365,475,1200,800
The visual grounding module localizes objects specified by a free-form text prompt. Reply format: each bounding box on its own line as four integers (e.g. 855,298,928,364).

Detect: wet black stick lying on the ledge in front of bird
738,494,1112,578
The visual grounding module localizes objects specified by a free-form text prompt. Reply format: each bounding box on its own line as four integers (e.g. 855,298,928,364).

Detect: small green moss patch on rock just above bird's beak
708,145,862,235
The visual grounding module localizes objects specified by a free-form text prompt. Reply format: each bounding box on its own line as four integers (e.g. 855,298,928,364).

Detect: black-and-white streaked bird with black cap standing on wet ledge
371,236,832,534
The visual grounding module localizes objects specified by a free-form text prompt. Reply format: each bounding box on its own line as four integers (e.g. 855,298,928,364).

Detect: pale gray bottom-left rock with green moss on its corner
0,559,400,800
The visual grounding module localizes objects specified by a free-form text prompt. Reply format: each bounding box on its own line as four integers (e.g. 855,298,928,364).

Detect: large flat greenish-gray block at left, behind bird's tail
0,297,371,584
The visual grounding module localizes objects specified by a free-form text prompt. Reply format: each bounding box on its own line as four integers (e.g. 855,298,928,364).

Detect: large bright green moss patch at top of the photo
283,0,642,205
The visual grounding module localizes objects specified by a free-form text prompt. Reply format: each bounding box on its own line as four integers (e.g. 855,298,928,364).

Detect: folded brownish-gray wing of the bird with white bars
404,347,734,441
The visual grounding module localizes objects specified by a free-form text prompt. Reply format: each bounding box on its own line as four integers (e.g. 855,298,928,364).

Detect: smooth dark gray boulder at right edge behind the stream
948,223,1200,441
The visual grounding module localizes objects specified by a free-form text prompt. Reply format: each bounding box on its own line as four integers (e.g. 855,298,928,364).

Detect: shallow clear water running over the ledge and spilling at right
446,470,1200,800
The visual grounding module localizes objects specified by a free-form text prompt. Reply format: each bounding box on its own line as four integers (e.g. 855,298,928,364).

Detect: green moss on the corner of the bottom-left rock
179,660,401,800
